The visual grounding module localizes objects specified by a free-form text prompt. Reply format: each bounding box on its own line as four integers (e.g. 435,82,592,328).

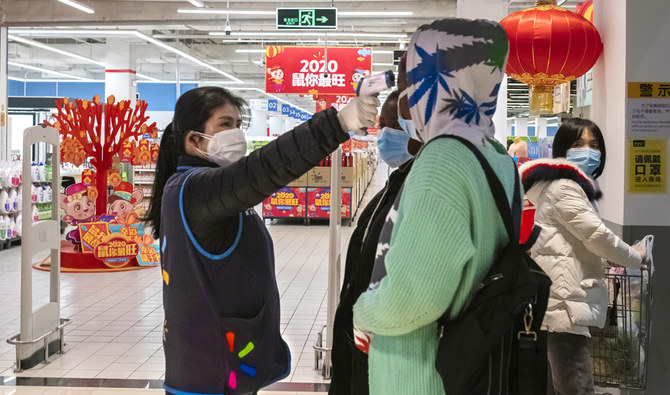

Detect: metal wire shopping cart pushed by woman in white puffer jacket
590,266,653,389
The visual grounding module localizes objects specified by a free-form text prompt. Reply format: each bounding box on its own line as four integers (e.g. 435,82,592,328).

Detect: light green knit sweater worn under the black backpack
354,139,515,395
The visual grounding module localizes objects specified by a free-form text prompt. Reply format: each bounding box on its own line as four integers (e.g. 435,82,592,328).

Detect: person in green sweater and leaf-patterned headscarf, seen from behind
354,19,516,395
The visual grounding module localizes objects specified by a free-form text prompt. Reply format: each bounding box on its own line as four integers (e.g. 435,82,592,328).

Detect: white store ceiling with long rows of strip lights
0,0,579,115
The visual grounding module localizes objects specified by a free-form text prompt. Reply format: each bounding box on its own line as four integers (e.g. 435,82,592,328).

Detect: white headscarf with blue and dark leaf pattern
407,18,509,145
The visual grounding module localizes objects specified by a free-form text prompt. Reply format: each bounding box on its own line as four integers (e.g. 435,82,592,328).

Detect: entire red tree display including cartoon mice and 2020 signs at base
45,95,160,272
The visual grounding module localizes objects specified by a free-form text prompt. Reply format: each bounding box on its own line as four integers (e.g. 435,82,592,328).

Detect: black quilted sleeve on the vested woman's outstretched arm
179,108,349,254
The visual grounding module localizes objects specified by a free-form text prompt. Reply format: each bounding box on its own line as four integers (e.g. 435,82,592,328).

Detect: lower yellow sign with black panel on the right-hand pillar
628,139,668,193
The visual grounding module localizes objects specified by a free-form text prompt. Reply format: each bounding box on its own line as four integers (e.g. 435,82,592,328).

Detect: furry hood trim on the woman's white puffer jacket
519,158,603,202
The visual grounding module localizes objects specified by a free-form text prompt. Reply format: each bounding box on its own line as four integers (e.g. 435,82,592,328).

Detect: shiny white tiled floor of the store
0,164,388,395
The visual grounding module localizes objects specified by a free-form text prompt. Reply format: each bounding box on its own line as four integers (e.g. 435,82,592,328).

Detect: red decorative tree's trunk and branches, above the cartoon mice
51,95,157,215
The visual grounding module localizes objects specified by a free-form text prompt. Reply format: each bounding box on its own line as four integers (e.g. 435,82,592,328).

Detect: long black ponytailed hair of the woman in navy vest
143,86,246,239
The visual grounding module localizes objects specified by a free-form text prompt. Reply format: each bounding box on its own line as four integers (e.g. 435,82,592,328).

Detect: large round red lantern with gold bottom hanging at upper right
500,0,603,115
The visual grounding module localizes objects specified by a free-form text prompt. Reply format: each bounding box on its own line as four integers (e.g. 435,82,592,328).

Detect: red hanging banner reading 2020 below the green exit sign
265,46,372,95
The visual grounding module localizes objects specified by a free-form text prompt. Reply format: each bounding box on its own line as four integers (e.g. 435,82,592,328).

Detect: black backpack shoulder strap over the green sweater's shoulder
429,134,521,243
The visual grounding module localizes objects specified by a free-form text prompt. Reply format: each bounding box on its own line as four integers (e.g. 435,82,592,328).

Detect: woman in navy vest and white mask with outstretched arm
146,87,379,395
